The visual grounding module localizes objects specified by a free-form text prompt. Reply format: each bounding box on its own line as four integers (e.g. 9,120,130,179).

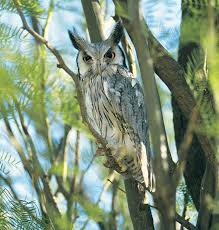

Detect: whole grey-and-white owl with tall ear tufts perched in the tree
68,22,155,191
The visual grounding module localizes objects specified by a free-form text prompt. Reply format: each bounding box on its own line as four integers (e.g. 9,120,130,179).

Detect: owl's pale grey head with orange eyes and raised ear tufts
68,21,125,77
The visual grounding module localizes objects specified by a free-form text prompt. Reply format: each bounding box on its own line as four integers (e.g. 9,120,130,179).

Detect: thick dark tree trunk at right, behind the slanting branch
172,1,217,230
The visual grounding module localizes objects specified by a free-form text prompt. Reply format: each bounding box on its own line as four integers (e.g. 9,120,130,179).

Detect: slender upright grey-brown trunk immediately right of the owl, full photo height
124,0,175,229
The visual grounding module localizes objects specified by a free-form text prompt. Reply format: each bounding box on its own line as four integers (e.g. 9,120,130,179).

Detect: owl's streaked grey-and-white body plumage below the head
82,65,154,190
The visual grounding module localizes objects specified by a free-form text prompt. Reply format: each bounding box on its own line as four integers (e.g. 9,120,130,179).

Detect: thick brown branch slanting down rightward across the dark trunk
145,23,214,164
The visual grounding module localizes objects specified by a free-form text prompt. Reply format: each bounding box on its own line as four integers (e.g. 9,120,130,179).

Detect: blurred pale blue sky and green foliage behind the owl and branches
0,0,209,230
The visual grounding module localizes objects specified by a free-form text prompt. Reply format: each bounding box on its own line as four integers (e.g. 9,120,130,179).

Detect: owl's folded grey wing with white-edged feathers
108,68,154,191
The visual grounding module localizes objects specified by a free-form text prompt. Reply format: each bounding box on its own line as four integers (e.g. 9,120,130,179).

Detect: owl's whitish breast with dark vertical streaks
83,76,124,143
